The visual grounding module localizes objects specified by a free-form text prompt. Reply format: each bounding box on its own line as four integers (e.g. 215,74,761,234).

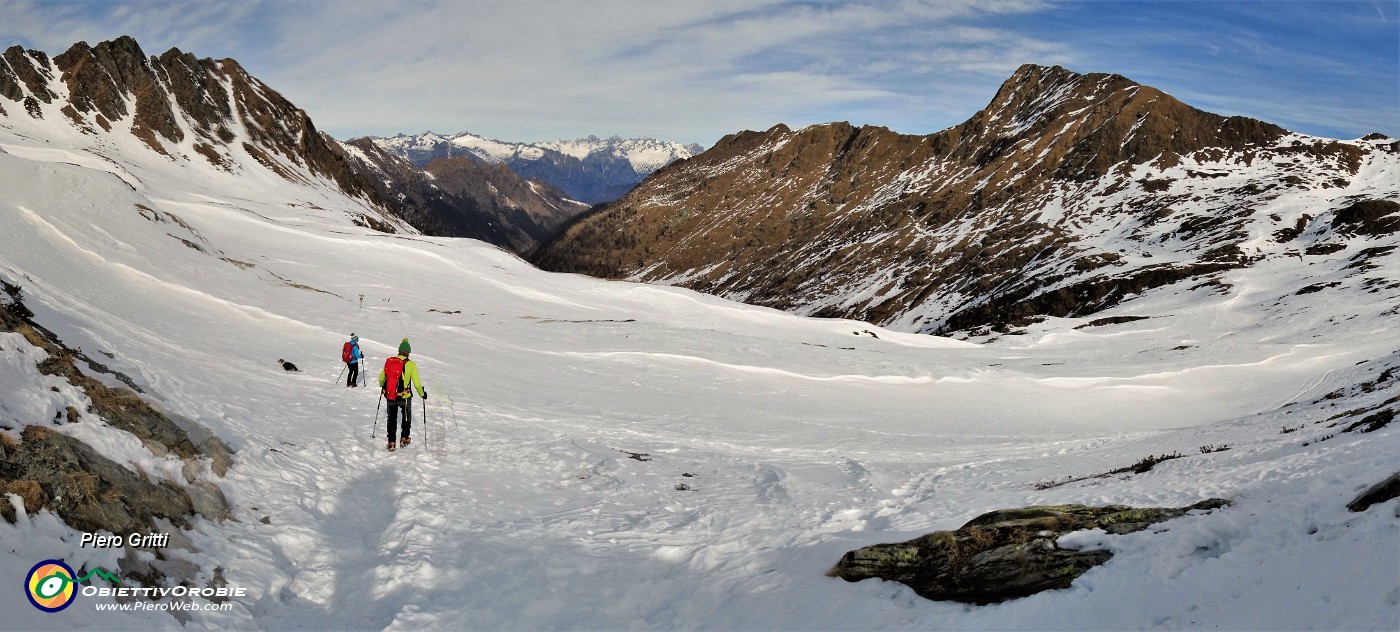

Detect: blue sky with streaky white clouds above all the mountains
0,0,1400,146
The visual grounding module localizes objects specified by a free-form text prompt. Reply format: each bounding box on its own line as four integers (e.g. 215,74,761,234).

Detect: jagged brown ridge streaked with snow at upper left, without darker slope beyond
0,36,378,196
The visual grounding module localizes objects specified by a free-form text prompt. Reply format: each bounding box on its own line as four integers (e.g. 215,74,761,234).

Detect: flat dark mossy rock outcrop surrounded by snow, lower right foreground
829,499,1229,604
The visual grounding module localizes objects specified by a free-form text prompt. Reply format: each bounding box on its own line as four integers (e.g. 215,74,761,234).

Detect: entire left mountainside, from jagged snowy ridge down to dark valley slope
0,36,587,254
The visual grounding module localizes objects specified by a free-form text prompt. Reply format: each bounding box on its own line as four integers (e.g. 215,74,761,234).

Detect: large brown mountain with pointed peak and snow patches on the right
535,66,1400,332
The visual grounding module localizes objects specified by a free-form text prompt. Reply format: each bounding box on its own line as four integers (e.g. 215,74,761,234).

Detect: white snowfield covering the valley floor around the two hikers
0,114,1400,629
